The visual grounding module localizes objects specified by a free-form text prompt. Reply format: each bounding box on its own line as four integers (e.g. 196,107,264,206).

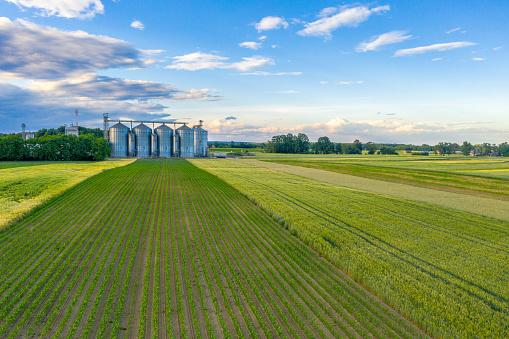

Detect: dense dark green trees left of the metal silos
0,132,111,161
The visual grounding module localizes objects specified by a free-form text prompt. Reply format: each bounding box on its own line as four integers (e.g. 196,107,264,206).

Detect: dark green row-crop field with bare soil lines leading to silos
0,160,424,338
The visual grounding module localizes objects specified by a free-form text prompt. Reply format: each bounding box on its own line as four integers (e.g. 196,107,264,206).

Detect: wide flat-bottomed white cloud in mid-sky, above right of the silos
166,52,275,71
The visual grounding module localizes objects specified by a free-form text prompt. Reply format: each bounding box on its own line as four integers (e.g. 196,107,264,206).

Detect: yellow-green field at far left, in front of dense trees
0,159,133,230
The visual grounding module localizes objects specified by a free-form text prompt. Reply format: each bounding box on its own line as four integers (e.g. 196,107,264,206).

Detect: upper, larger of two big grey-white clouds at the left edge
0,18,150,79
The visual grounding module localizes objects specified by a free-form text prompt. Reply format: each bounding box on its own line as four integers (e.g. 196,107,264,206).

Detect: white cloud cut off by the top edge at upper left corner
6,0,104,19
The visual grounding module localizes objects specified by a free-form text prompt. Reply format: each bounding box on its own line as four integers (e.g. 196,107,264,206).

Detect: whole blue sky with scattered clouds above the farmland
0,0,509,144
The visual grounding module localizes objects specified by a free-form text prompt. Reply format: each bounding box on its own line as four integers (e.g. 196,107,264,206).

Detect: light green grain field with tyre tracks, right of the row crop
192,160,509,338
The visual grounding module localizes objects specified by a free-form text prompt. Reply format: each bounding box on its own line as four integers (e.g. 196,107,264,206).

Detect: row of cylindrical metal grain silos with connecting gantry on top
103,113,209,158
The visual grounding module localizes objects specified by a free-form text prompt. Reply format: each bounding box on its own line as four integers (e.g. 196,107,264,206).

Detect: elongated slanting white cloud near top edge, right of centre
297,5,390,38
